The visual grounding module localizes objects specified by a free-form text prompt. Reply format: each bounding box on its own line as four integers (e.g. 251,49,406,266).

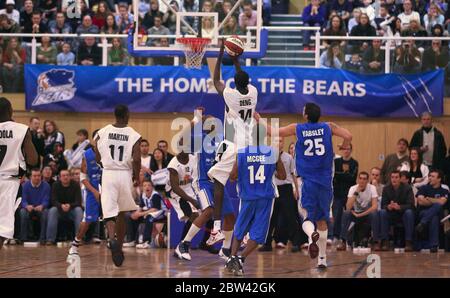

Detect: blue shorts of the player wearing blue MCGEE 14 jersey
234,199,274,244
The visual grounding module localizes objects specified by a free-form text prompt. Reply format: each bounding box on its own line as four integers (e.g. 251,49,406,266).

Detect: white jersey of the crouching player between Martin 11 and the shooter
166,154,196,199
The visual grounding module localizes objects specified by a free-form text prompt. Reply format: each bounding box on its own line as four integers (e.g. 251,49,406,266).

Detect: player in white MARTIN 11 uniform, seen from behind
94,105,141,266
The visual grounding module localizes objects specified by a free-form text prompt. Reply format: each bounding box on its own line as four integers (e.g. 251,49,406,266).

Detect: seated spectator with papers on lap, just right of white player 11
126,181,167,248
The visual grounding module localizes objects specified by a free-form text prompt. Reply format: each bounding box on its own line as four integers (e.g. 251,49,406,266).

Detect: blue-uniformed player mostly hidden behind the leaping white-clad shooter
175,109,235,260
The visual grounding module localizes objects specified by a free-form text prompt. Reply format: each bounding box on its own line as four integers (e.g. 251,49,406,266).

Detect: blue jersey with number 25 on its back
295,122,334,186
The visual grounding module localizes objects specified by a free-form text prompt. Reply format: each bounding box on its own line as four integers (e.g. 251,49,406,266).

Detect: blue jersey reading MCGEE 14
237,146,276,200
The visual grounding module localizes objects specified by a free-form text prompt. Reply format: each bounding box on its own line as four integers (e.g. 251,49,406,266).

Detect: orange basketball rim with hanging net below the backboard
177,37,211,69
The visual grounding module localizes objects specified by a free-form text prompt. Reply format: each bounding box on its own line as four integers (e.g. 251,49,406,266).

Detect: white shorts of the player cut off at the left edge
0,178,21,239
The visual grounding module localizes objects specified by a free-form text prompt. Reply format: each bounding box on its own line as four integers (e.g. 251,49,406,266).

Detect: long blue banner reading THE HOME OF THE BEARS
25,65,444,117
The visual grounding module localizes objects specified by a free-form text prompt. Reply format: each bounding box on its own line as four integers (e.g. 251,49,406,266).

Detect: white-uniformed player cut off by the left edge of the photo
0,97,38,249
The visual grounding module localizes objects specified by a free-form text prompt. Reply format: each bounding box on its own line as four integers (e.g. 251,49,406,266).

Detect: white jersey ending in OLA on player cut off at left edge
0,121,28,178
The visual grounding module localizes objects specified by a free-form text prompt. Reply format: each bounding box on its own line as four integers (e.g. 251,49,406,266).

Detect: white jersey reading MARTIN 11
97,124,141,170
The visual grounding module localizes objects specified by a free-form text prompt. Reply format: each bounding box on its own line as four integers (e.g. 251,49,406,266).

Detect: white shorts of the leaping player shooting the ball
208,140,237,185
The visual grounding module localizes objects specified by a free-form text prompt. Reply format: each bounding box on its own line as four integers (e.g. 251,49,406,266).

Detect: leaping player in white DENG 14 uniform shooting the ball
207,42,258,245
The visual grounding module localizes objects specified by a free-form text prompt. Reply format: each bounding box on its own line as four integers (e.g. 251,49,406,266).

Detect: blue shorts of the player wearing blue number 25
299,179,333,222
